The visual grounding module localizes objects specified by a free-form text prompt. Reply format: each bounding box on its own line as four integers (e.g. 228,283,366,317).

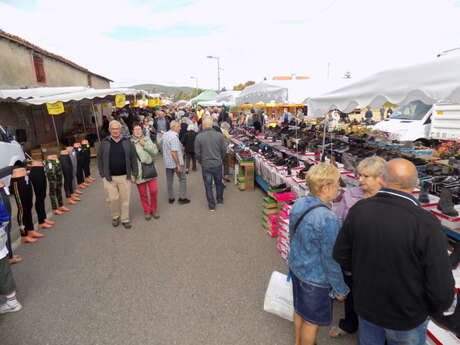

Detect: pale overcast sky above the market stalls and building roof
0,0,460,88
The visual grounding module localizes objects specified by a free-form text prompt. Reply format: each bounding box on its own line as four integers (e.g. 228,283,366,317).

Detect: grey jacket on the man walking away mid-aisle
195,128,227,168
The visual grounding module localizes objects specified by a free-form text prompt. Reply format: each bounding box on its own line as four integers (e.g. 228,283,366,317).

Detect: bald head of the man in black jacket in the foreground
382,158,418,193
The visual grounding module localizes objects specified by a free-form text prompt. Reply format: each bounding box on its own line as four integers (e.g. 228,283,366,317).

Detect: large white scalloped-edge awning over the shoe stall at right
306,55,460,117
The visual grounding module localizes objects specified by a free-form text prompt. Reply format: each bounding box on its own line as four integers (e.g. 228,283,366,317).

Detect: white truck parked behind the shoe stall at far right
373,101,460,142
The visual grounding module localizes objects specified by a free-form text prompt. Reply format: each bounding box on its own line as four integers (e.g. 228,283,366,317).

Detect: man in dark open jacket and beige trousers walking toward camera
97,120,138,229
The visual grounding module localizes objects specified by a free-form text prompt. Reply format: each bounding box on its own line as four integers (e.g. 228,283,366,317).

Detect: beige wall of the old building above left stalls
0,38,110,89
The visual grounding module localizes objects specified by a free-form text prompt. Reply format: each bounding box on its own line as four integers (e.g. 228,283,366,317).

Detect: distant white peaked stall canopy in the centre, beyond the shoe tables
235,81,288,105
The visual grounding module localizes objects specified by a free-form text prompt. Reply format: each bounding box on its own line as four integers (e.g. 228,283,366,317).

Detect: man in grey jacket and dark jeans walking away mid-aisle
195,116,226,211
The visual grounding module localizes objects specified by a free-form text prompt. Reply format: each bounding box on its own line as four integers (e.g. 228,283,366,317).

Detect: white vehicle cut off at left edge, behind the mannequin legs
0,126,25,186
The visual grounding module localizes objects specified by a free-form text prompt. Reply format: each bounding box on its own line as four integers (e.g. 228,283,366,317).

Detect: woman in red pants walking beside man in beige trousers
131,124,160,220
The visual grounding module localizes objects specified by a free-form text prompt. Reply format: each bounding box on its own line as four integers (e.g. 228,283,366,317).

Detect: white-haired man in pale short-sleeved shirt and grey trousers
161,121,190,205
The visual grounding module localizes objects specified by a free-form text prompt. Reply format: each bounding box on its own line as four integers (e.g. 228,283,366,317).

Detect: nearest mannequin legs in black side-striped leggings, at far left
10,168,44,243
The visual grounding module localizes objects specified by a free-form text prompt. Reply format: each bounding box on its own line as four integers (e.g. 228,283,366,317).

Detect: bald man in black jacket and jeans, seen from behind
333,158,455,345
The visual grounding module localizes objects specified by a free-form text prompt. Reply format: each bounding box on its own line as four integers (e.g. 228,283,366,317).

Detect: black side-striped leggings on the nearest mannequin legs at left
10,176,34,236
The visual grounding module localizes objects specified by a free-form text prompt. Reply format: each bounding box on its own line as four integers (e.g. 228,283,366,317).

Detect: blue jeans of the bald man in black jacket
359,316,428,345
